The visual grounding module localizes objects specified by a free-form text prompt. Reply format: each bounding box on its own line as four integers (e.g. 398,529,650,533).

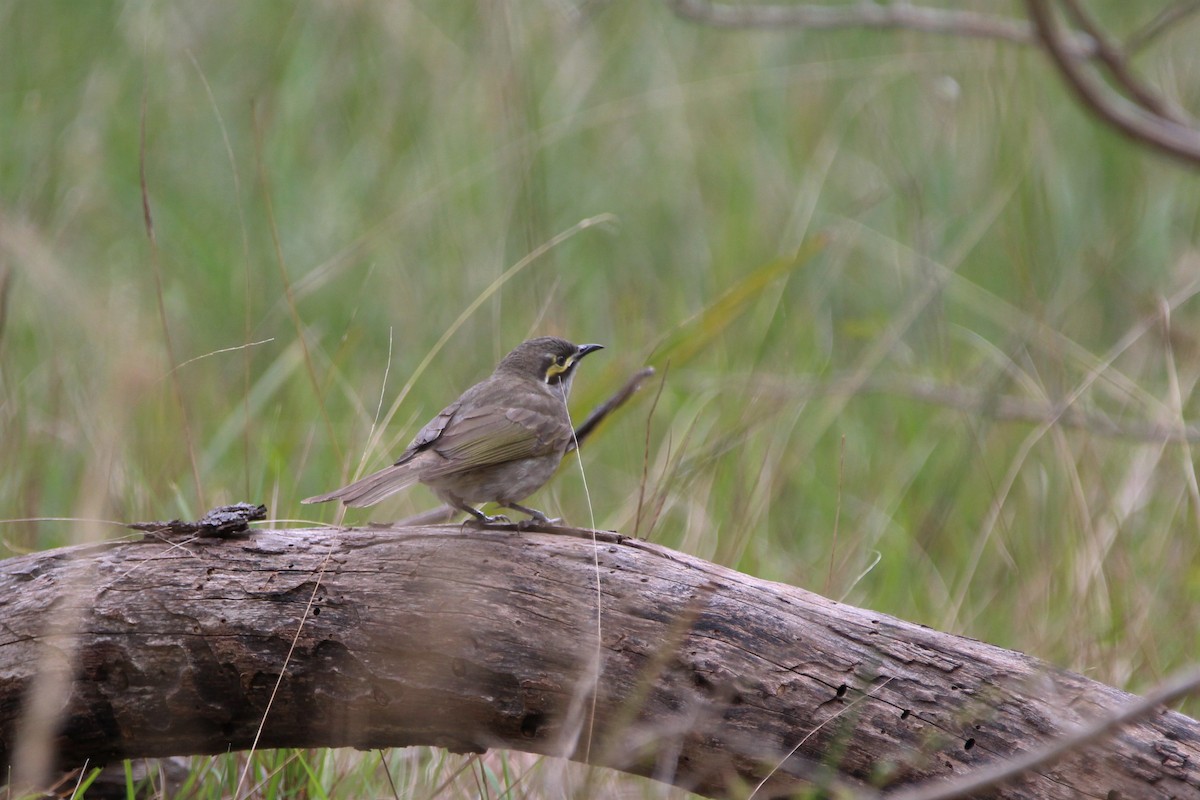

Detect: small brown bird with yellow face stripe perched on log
302,336,602,525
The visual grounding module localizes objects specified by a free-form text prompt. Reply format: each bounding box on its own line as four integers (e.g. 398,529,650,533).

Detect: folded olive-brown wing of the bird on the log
421,405,571,479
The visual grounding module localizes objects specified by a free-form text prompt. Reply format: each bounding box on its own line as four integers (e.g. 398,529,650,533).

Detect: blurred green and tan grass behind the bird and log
0,0,1200,794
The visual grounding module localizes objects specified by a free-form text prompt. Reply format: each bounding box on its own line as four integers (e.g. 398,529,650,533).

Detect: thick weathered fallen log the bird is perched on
0,525,1200,800
